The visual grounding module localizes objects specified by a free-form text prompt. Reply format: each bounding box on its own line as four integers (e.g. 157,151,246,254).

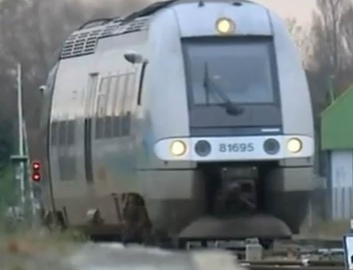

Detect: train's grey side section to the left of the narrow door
50,53,92,223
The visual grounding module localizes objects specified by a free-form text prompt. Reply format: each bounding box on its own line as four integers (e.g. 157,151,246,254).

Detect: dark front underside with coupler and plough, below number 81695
175,163,309,250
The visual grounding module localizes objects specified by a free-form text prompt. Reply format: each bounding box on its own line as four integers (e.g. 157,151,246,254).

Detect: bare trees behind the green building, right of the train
307,0,352,121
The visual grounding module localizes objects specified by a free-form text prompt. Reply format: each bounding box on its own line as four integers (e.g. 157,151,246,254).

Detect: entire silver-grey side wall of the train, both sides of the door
50,30,150,225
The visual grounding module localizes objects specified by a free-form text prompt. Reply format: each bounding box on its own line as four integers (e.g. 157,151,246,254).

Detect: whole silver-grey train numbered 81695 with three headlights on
37,0,314,247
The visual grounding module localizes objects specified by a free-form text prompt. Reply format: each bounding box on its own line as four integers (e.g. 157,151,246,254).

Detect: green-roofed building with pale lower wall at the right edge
321,85,353,220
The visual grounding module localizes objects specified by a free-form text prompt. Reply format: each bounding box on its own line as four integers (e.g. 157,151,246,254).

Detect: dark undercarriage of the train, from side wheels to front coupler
42,163,309,250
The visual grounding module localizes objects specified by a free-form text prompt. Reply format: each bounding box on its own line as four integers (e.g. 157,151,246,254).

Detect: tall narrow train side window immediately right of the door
95,78,110,139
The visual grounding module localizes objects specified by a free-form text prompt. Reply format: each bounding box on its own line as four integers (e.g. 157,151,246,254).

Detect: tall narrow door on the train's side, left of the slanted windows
84,73,98,184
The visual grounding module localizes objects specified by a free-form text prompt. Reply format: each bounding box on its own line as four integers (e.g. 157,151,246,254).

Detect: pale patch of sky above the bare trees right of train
253,0,316,26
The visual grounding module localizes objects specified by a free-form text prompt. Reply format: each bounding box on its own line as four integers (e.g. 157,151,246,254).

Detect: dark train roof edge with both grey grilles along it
59,0,259,59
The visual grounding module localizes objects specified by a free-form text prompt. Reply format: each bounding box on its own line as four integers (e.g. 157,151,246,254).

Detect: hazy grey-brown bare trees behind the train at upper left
0,0,148,163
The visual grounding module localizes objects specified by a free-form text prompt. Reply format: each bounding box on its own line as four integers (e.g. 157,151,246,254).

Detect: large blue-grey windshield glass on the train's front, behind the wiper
183,38,275,105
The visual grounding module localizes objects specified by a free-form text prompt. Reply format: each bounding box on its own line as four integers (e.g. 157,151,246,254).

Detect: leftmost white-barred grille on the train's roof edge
60,29,102,59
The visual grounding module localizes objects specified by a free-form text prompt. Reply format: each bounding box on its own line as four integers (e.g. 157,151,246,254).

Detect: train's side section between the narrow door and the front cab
87,32,148,224
